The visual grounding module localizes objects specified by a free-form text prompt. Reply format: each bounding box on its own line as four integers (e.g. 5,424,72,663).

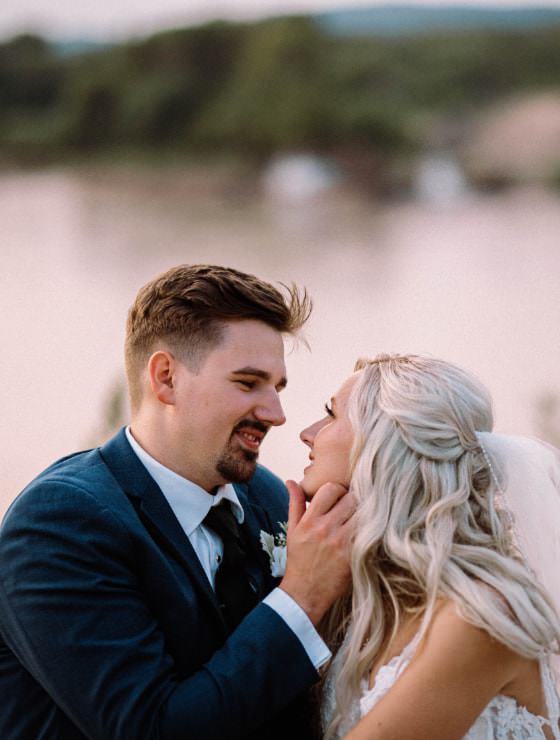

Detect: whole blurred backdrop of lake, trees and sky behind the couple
0,0,560,511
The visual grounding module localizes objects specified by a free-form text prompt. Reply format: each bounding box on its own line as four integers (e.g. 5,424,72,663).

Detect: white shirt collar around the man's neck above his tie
125,427,245,536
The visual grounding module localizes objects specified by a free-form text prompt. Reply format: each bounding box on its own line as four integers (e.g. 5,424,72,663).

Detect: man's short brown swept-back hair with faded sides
125,265,312,410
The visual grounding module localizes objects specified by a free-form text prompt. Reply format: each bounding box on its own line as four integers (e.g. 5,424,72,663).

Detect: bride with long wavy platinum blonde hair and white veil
301,355,560,740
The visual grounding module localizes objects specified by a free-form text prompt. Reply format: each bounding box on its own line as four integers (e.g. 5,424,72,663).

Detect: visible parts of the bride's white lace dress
321,637,560,740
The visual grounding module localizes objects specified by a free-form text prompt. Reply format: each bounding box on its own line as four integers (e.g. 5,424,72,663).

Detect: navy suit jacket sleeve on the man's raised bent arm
0,482,317,740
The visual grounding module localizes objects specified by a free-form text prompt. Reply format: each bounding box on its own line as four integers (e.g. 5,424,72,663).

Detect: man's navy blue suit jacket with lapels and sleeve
0,430,317,740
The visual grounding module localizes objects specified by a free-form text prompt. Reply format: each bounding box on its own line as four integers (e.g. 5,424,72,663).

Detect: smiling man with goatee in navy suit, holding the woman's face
0,265,353,740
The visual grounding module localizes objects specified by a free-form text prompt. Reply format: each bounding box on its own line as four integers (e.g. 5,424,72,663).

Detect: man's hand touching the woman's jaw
280,481,356,625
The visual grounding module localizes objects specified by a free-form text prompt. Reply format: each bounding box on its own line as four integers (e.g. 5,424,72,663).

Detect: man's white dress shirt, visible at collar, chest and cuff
126,427,331,669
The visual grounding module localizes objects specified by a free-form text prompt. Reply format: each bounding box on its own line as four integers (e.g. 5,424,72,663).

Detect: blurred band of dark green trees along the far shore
0,17,560,162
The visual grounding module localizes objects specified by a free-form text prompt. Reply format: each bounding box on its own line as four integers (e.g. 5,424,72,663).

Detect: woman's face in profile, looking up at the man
300,371,361,498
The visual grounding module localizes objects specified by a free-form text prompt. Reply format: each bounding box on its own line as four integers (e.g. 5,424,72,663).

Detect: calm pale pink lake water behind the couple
0,166,560,509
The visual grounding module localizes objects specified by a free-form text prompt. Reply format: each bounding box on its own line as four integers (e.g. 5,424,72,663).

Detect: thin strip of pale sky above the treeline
0,0,560,39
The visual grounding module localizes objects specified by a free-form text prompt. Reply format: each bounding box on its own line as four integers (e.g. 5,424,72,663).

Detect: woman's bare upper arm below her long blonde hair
346,602,524,740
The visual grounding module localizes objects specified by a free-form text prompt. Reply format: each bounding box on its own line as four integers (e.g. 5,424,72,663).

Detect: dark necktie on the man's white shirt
203,501,258,629
